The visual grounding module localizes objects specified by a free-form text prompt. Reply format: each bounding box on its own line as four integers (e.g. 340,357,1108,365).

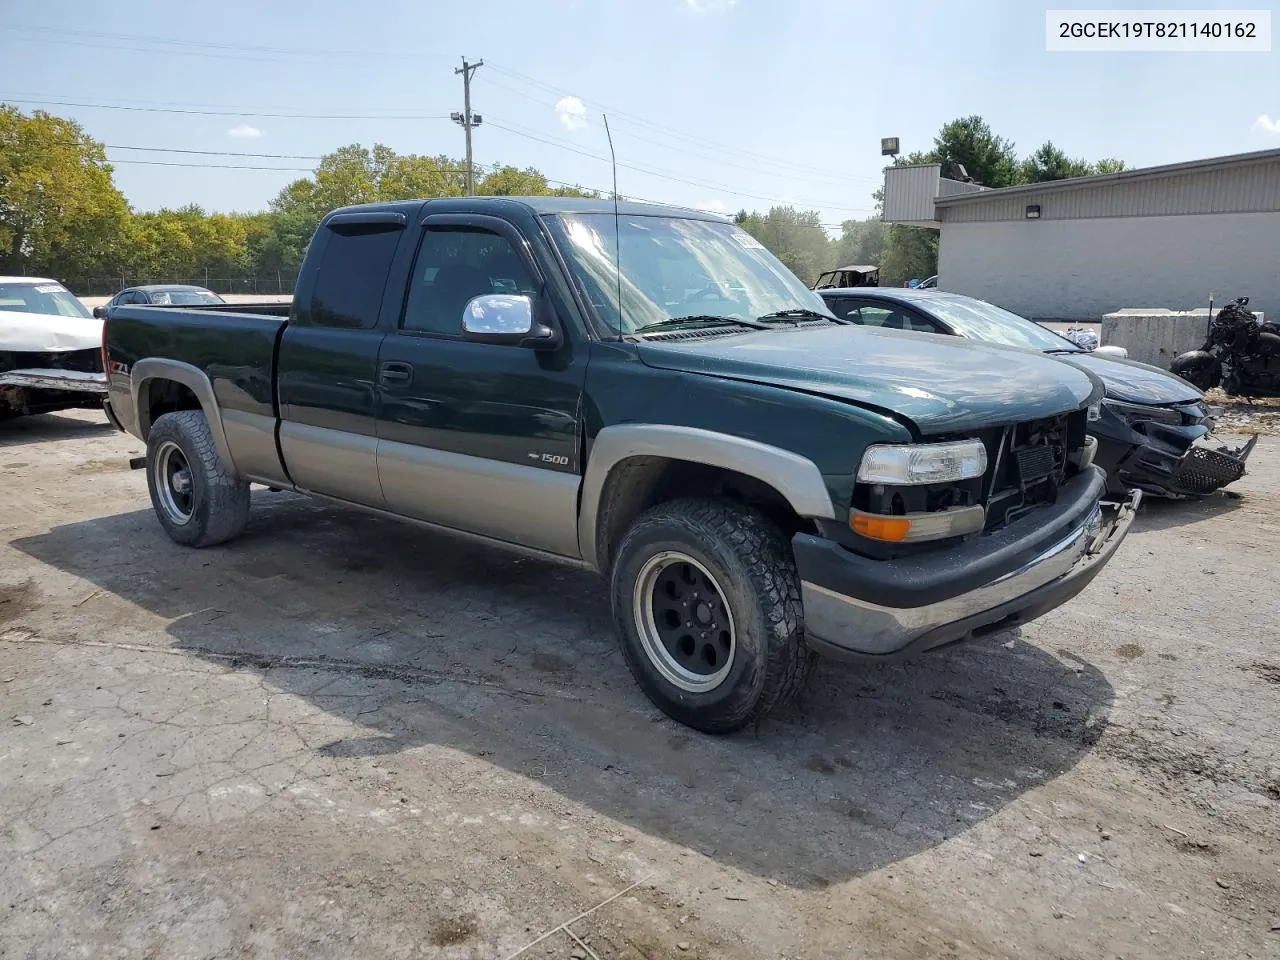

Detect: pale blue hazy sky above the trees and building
0,0,1280,230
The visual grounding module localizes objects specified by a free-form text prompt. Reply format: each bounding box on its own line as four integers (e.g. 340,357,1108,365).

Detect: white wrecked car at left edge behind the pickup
0,276,106,420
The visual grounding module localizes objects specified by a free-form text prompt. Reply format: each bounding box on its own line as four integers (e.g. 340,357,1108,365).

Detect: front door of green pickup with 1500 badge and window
378,214,586,557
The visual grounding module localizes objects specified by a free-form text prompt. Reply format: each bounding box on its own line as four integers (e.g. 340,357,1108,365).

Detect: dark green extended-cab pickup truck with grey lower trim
102,197,1137,732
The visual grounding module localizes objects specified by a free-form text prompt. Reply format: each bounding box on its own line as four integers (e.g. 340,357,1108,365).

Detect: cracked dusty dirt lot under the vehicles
0,412,1280,960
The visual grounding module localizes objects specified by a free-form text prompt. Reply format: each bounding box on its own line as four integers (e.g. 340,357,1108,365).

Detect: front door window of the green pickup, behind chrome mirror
401,227,536,337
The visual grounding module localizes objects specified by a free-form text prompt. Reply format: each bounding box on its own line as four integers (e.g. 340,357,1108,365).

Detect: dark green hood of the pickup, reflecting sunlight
639,326,1102,434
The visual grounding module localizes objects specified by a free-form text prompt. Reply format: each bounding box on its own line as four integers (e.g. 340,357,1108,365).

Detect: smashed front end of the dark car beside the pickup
1091,399,1257,499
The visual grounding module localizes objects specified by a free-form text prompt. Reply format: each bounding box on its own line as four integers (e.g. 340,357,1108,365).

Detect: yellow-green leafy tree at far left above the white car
0,104,128,279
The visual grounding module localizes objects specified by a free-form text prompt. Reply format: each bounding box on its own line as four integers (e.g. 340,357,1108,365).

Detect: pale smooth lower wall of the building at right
938,212,1280,323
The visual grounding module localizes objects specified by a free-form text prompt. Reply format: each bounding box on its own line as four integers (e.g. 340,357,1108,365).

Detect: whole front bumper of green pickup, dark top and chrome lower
792,468,1142,659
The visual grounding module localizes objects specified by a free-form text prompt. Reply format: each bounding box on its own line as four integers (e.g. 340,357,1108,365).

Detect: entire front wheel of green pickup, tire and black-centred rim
612,499,810,733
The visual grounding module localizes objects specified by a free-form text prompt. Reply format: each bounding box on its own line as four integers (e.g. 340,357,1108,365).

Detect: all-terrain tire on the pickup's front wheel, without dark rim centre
611,498,813,733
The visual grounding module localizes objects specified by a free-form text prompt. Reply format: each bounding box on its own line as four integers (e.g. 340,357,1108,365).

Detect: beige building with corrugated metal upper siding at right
884,150,1280,321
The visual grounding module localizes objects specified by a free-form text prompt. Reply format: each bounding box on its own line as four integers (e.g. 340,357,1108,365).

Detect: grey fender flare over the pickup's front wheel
577,424,836,570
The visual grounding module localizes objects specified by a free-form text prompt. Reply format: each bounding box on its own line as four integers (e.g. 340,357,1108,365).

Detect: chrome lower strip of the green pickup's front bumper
800,490,1142,658
